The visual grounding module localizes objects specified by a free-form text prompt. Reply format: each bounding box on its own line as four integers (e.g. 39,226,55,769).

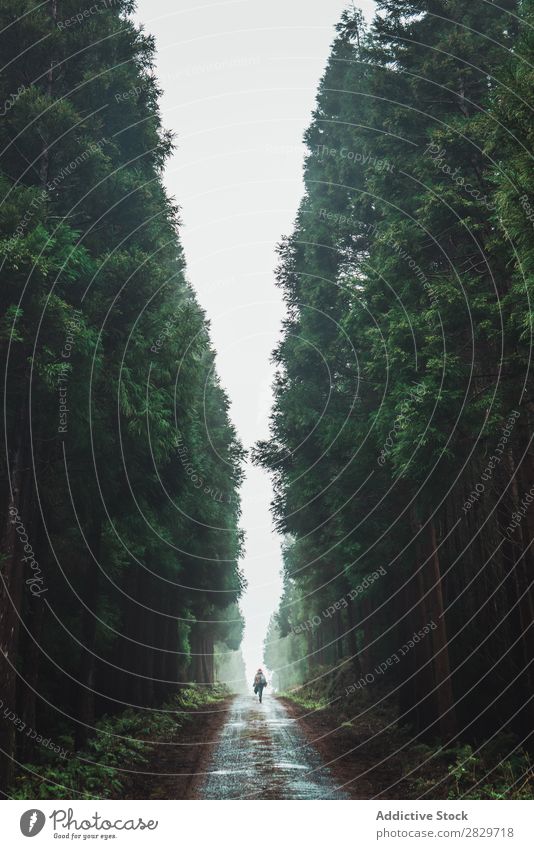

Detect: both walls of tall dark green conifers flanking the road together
0,0,534,793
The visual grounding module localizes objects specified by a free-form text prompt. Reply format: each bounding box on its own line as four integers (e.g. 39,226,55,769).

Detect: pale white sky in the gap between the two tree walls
137,0,373,679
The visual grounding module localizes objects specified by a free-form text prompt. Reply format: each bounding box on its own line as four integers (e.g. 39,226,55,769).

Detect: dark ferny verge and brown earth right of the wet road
277,677,534,800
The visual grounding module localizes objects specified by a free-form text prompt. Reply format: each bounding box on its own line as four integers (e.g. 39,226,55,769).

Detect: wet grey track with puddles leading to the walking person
198,694,348,799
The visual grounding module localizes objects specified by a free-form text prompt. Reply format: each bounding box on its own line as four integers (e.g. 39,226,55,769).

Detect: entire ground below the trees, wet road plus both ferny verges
10,678,534,800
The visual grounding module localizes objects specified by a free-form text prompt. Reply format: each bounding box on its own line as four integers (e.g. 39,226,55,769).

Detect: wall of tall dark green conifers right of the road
262,0,534,753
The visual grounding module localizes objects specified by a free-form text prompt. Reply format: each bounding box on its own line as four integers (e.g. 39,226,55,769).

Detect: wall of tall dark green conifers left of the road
0,0,244,795
